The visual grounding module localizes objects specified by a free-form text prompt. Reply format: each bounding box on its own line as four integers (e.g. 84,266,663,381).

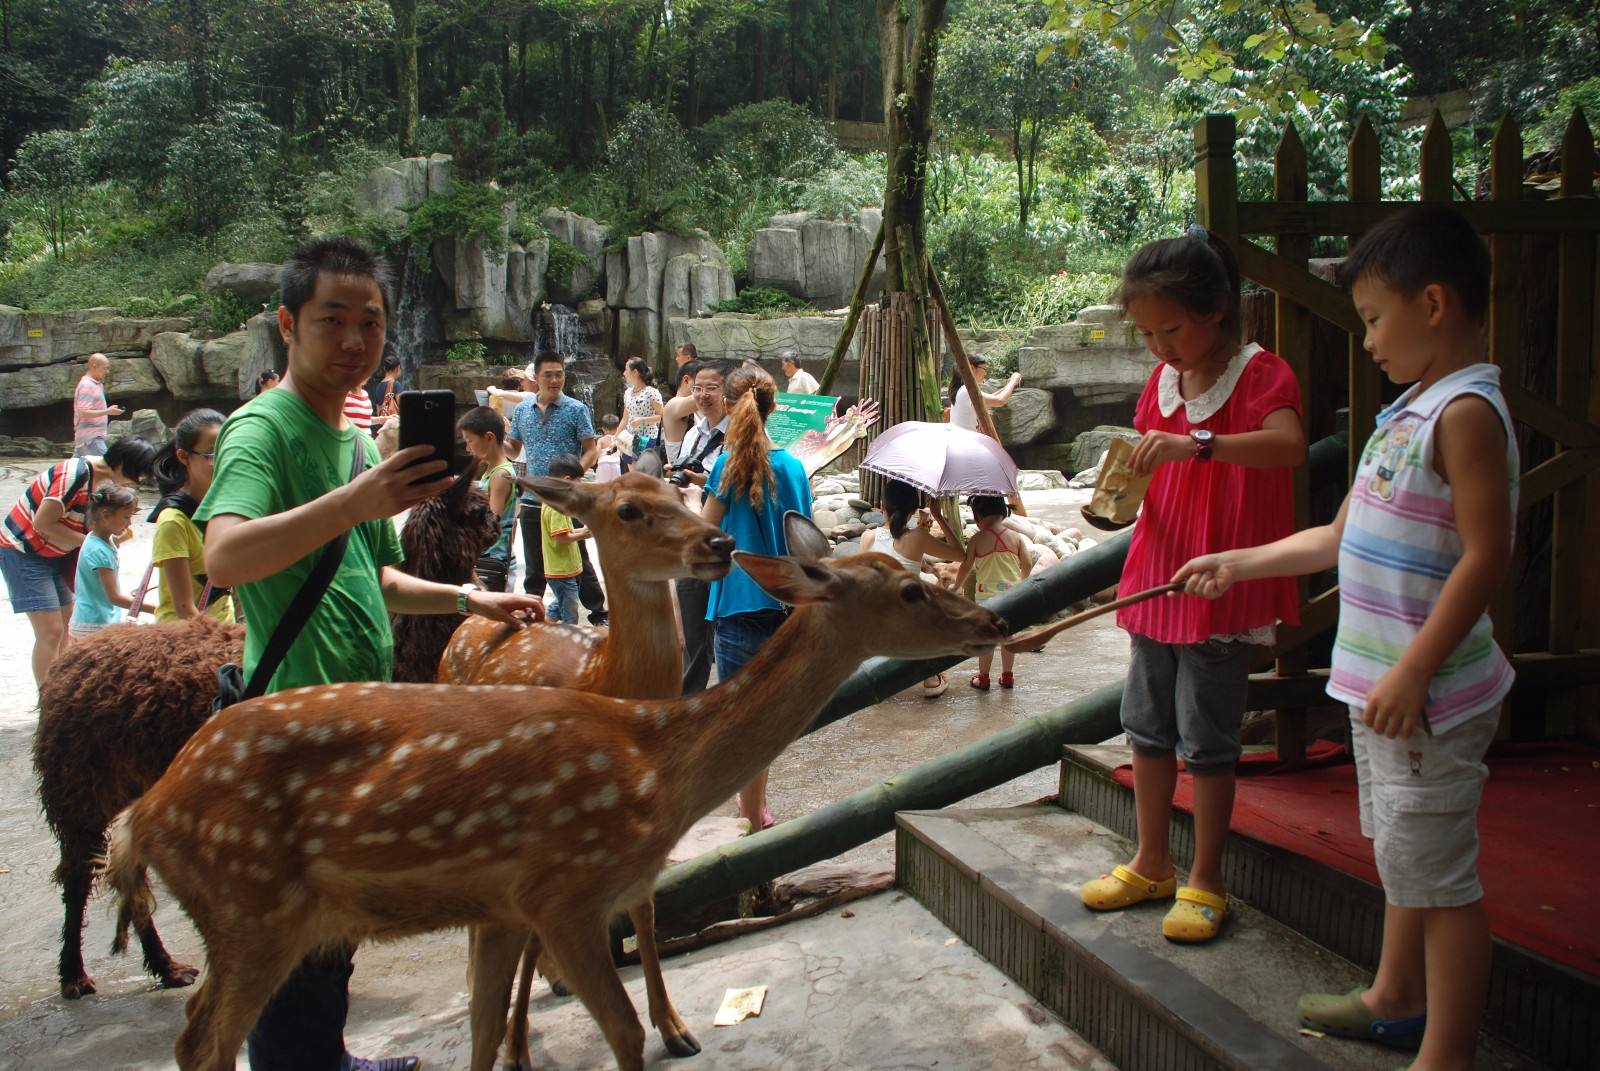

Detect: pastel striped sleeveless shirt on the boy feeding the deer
1328,363,1520,733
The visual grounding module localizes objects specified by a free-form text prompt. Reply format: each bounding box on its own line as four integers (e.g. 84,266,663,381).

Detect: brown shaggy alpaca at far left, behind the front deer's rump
34,618,245,999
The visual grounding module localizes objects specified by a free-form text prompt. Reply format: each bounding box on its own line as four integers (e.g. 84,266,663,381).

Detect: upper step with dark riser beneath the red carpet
1059,746,1600,1071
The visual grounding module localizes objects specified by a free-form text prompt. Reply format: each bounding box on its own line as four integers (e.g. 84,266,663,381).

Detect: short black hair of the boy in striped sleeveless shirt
1334,205,1490,320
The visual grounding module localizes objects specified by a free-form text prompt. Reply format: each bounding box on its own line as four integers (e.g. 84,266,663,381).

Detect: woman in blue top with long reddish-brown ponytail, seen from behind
701,365,811,829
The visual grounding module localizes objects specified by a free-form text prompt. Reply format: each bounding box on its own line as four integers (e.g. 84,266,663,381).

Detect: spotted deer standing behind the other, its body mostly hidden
438,472,733,1071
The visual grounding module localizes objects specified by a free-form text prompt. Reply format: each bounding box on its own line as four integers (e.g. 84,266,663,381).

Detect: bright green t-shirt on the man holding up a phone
195,389,403,693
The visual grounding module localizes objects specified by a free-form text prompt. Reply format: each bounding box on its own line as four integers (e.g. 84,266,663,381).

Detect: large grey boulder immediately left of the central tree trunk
749,208,883,309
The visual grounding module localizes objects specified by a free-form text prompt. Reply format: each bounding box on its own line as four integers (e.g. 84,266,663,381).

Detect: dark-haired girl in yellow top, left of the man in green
150,410,234,621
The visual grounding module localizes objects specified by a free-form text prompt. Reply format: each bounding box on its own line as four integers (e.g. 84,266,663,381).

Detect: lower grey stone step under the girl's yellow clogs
896,804,1538,1071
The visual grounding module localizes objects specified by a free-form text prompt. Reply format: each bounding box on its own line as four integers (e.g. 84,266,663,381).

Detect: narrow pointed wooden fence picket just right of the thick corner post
1272,122,1312,760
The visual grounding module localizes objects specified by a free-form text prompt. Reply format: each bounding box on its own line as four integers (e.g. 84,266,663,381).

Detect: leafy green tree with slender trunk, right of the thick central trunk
939,0,1131,231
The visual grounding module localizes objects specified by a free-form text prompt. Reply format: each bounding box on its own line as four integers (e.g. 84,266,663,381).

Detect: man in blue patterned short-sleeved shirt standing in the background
506,352,606,624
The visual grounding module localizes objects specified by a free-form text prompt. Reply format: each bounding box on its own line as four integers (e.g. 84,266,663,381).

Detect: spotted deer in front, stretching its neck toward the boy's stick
106,519,1005,1071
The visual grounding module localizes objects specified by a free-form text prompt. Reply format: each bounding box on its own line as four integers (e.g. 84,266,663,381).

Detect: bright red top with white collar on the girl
1117,344,1301,644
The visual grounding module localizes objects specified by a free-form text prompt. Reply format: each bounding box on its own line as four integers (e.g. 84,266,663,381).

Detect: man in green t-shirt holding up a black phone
195,239,542,1071
